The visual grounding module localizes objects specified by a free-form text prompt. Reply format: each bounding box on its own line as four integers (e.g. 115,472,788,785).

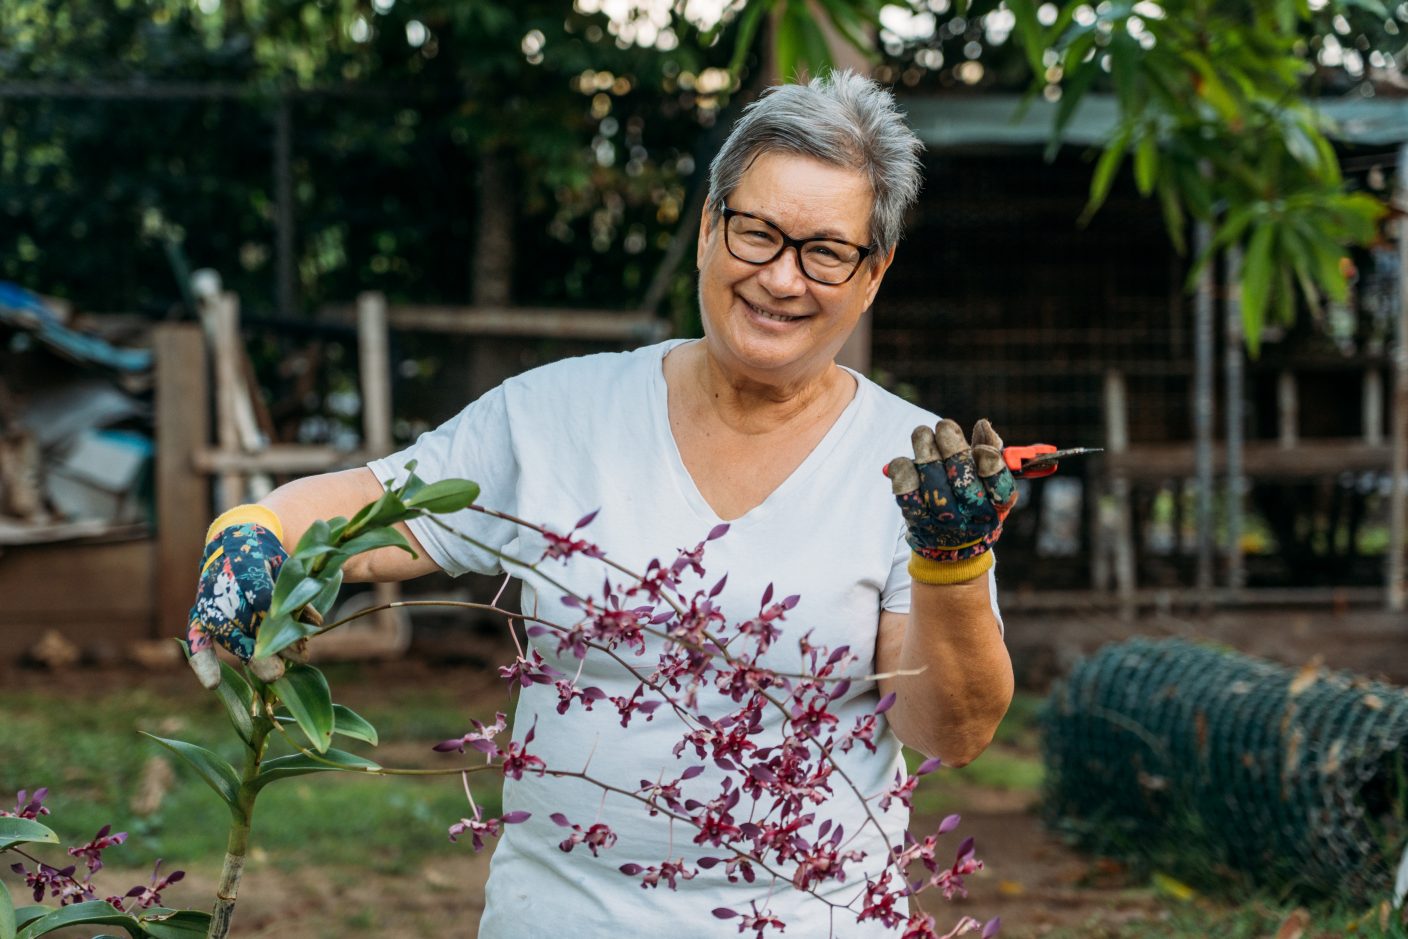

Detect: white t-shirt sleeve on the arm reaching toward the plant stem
367,386,518,577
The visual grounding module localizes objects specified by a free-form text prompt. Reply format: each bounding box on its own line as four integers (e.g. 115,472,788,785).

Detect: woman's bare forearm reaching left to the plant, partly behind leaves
259,467,436,583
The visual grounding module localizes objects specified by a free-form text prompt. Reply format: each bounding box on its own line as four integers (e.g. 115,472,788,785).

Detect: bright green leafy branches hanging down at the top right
974,0,1387,355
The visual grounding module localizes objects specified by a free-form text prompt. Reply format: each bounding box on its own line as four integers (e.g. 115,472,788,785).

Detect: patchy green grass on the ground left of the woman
0,670,500,873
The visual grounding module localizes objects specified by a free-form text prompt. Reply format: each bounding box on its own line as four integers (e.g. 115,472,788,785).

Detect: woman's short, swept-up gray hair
708,69,924,256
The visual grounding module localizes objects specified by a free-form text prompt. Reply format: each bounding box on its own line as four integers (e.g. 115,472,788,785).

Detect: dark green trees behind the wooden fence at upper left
8,0,725,315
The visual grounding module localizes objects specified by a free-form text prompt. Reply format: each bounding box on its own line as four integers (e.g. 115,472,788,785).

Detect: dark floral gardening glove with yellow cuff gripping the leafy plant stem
186,505,303,688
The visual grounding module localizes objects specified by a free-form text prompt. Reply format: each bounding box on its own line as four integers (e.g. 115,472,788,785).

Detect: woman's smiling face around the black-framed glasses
698,153,894,384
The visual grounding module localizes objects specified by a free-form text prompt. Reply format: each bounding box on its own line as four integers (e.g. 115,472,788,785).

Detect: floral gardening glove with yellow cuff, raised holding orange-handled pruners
886,420,1017,584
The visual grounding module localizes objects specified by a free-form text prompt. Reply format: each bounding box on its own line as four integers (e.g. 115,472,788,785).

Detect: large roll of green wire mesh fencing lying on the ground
1042,639,1408,901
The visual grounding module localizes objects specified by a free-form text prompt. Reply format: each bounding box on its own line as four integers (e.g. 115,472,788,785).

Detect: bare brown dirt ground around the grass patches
0,660,1164,939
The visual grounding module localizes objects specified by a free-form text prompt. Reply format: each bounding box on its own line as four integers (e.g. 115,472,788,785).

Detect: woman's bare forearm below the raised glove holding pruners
880,573,1014,766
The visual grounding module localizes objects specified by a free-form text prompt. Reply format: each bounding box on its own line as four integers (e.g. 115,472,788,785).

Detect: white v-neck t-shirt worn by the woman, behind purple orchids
369,341,997,939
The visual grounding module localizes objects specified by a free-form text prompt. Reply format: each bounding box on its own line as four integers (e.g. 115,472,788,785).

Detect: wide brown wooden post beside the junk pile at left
152,322,210,636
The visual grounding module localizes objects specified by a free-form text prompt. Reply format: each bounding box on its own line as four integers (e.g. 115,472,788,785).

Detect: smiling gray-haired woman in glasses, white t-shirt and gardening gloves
191,73,1015,938
